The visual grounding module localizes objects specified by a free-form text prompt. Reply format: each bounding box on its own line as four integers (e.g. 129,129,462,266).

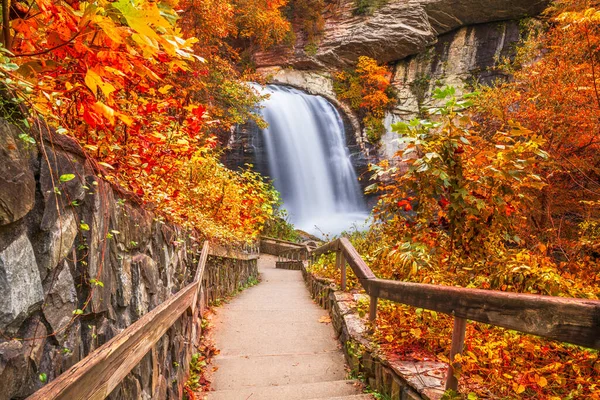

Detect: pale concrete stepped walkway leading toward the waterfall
207,255,371,400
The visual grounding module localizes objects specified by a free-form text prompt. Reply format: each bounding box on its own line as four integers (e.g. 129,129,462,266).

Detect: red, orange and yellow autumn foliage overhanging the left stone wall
2,0,288,241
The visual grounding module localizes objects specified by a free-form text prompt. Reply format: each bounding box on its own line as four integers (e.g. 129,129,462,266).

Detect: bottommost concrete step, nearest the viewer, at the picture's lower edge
204,380,372,400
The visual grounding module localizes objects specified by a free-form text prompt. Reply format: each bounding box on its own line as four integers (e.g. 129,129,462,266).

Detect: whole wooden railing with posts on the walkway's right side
310,238,600,390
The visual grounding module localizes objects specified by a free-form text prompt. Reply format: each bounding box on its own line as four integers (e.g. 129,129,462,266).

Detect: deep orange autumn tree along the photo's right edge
480,1,600,271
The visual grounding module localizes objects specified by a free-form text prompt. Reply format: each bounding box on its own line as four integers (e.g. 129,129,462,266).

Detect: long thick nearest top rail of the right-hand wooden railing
361,279,600,350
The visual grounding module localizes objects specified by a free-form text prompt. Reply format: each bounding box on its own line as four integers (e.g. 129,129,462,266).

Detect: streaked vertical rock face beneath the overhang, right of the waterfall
379,21,521,159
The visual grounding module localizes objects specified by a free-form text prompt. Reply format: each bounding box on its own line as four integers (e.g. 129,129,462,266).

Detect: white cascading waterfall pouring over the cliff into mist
256,85,368,236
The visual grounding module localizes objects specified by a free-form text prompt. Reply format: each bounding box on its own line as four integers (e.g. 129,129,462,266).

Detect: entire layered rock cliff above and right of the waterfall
255,0,548,161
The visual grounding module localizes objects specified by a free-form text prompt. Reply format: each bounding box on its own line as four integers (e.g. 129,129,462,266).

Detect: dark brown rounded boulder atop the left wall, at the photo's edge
0,121,35,226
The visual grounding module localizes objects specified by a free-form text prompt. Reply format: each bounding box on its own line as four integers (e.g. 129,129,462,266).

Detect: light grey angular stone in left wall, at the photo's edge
0,234,44,330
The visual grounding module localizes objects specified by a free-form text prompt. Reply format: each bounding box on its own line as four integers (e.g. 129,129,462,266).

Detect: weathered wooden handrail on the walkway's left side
28,242,210,400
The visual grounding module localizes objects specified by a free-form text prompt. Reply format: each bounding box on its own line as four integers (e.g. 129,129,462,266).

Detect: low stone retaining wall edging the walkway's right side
302,269,448,400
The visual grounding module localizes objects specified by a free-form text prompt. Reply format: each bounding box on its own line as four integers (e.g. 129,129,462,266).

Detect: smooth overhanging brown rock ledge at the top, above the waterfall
254,0,549,69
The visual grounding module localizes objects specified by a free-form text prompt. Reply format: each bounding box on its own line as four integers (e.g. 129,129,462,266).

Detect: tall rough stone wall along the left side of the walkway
0,121,257,400
